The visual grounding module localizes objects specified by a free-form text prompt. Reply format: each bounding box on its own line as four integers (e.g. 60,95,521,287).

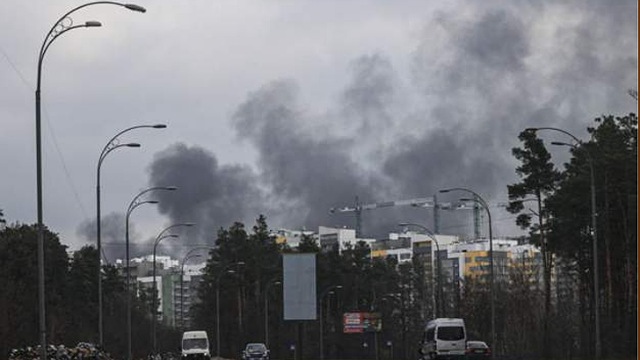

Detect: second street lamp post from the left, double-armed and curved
96,124,167,346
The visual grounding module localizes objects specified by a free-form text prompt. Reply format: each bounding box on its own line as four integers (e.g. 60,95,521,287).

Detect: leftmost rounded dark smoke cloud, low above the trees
149,144,266,253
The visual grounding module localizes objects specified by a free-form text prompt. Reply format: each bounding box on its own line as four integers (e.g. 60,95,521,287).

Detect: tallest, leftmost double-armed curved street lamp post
35,1,146,359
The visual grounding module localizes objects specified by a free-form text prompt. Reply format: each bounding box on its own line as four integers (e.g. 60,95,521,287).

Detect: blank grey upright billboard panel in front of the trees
282,254,316,320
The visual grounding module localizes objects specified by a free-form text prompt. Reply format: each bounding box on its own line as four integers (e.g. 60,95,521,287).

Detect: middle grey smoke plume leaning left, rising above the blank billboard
234,81,388,229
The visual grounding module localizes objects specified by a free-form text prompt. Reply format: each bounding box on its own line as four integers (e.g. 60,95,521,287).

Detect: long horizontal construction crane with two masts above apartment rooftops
329,195,470,238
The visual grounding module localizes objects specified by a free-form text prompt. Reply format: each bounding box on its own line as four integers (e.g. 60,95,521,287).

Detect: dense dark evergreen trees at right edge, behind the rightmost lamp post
547,114,638,356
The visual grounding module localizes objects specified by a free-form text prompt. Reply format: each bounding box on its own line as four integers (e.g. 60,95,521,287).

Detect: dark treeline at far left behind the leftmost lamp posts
0,224,180,359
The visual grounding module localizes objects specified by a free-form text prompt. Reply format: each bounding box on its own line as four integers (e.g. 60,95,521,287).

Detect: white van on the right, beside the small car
418,318,467,360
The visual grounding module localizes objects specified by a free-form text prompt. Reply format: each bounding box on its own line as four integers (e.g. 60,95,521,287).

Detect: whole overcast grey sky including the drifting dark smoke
0,0,638,261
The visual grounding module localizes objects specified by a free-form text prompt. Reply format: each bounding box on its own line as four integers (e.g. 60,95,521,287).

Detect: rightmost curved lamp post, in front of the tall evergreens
526,127,602,360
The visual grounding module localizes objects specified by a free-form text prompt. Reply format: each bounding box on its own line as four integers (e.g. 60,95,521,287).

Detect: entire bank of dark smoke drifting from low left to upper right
141,1,637,243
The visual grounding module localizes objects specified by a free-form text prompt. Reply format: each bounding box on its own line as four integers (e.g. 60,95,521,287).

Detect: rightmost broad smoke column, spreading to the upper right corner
383,1,637,233
